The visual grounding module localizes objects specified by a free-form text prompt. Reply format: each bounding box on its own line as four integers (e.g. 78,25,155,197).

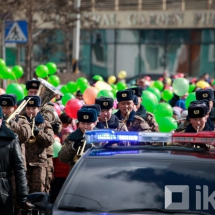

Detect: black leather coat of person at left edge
0,125,28,215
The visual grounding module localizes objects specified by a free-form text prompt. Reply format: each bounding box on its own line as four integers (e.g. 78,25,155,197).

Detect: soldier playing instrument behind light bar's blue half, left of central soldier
96,97,128,131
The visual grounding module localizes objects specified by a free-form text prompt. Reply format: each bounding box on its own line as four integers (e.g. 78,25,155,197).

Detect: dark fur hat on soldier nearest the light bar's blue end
78,108,98,122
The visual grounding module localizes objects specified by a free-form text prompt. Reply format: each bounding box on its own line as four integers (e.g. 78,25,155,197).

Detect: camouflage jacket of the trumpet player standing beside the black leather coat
25,113,54,166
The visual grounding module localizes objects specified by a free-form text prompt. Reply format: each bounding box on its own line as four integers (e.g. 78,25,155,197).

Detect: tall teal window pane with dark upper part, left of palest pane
91,44,115,78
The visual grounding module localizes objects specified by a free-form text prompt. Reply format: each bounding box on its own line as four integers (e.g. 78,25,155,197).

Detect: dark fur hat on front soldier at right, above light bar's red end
188,102,208,118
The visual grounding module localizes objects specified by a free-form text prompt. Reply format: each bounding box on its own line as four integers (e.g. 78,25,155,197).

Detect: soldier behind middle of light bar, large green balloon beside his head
115,89,151,132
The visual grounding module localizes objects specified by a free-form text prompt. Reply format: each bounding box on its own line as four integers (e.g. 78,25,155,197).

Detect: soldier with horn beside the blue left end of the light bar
58,108,98,168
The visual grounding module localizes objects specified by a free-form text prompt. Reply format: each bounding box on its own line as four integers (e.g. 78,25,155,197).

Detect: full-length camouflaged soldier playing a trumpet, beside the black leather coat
24,96,54,215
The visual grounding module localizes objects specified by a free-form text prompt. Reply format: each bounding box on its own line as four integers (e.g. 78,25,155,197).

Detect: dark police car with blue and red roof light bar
27,130,215,215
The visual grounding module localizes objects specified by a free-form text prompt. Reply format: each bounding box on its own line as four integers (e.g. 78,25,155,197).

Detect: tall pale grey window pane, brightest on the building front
116,45,139,77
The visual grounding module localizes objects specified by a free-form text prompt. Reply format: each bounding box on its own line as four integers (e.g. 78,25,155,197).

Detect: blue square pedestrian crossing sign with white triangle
5,20,28,43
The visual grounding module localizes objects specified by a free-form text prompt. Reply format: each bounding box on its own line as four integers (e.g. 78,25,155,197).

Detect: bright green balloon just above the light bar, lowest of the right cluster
159,116,178,132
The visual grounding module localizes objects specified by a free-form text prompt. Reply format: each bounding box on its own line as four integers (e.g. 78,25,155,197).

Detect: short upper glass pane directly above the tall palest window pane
116,30,139,43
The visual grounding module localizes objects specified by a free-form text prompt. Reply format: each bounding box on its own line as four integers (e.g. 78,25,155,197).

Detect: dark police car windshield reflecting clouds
58,152,215,214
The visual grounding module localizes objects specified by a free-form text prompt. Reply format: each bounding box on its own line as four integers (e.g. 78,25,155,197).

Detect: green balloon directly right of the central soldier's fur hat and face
142,91,158,113
